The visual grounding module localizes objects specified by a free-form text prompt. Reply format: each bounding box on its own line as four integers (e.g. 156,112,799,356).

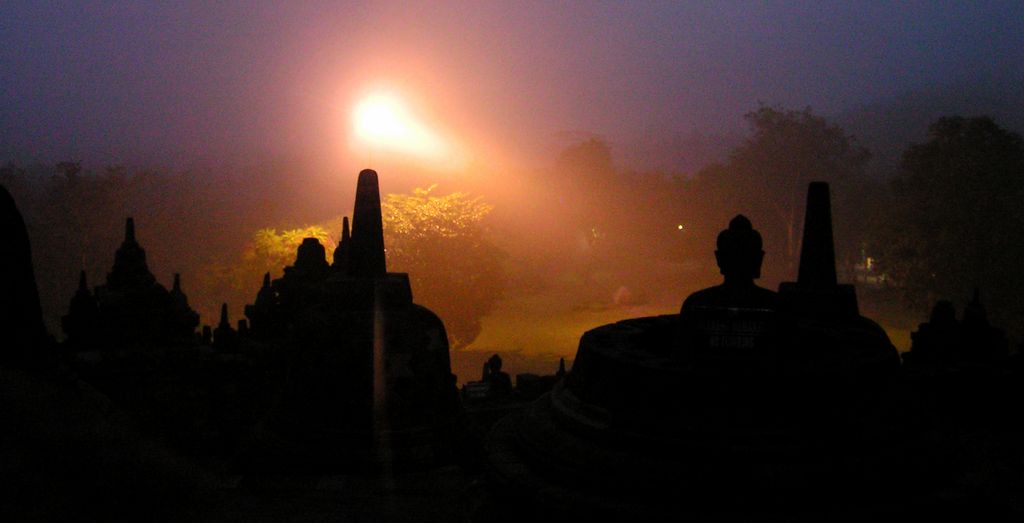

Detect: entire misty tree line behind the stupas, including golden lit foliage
0,106,1024,345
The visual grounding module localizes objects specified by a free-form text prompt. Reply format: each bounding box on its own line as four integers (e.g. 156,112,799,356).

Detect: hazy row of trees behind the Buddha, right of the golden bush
558,106,1024,343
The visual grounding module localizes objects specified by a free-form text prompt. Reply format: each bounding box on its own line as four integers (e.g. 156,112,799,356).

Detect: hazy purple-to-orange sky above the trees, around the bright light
0,0,1024,171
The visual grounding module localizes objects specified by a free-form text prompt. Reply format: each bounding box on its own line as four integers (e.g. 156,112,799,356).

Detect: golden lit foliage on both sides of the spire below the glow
216,186,505,348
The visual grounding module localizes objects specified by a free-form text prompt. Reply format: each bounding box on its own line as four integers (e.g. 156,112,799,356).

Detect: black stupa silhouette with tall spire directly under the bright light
244,170,458,472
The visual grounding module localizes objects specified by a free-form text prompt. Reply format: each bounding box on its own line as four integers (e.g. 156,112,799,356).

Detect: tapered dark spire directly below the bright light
348,169,387,277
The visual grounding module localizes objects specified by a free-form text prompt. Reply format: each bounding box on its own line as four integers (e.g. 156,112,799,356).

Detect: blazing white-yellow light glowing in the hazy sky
353,93,452,161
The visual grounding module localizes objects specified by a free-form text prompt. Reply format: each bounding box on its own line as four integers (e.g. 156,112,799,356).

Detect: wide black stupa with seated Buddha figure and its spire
481,183,905,521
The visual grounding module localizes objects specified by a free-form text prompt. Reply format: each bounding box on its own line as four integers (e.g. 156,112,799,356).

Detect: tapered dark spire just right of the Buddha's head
797,181,838,288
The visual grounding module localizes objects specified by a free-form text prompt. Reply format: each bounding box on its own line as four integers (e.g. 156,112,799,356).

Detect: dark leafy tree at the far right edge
874,117,1024,331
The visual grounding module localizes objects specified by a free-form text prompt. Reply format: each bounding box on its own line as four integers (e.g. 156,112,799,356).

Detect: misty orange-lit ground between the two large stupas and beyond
452,245,927,384
